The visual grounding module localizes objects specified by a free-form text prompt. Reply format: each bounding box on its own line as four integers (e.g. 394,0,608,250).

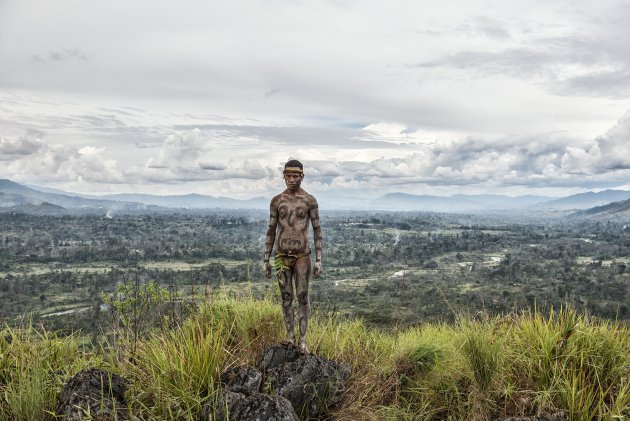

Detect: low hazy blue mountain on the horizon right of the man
370,193,553,212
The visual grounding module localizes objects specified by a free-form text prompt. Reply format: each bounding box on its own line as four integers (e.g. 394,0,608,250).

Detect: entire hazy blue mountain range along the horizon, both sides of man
0,180,630,215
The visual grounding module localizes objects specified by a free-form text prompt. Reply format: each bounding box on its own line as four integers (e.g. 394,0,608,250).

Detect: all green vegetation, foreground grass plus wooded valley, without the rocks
0,211,630,420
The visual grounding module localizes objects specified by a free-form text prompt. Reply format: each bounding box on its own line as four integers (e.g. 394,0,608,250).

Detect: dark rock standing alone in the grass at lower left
55,368,129,421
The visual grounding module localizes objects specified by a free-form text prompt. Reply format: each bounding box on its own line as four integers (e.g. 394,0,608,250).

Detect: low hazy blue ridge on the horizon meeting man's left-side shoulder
100,193,269,209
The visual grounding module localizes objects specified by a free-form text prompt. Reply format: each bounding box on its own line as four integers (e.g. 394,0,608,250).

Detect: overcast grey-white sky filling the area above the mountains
0,0,630,199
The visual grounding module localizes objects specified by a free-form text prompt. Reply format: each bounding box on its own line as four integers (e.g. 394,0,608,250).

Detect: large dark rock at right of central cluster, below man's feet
266,355,351,420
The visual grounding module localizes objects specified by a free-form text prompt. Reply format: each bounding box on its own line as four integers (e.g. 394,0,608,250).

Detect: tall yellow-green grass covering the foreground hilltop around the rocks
0,295,630,420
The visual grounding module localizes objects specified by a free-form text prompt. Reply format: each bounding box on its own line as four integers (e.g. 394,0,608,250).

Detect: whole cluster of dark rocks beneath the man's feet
209,344,350,421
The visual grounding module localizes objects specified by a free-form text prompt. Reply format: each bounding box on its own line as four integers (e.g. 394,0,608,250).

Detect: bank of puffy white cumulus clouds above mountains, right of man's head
308,113,630,187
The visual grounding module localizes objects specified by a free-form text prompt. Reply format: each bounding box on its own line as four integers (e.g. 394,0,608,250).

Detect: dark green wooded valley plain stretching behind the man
0,210,630,333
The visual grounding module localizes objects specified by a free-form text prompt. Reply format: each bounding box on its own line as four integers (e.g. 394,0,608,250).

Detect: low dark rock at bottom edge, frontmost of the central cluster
203,390,299,421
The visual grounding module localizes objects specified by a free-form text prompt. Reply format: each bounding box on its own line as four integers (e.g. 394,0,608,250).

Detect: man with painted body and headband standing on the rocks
263,159,322,354
